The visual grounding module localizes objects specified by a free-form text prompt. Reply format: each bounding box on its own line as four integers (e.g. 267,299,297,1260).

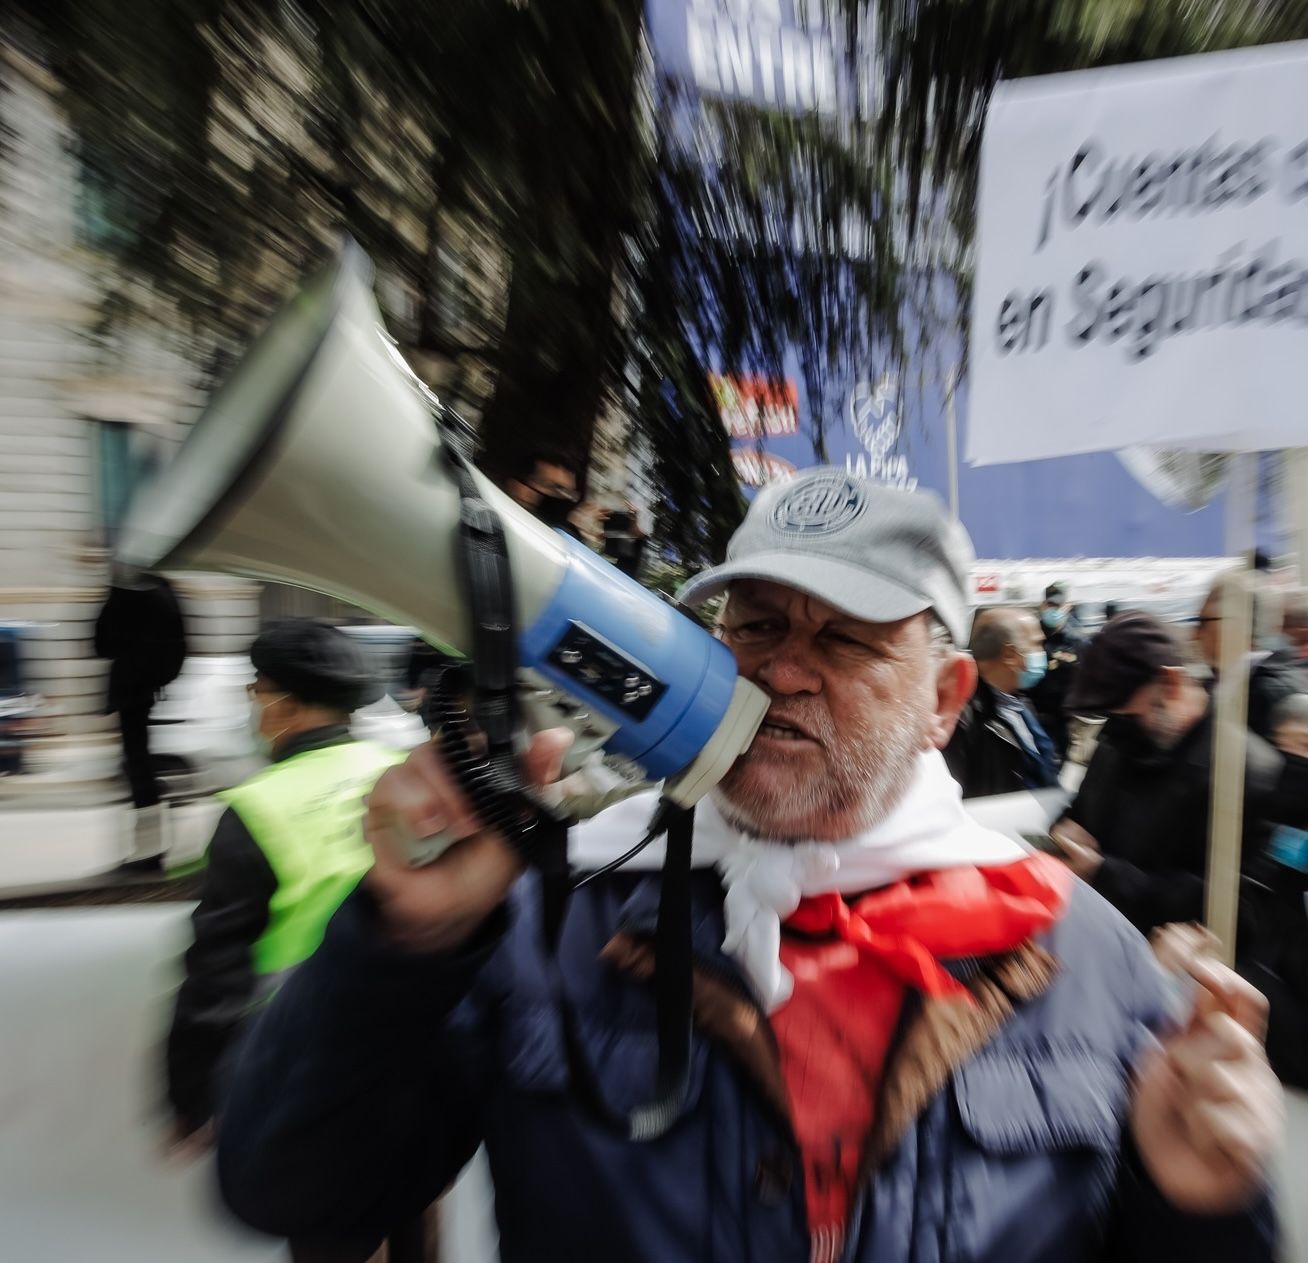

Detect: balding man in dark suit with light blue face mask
944,609,1058,798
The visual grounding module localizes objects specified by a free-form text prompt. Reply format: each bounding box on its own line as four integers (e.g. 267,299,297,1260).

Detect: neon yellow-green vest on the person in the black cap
218,741,404,974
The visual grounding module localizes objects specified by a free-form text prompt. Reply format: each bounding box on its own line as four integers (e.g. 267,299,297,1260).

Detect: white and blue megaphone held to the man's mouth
116,239,768,807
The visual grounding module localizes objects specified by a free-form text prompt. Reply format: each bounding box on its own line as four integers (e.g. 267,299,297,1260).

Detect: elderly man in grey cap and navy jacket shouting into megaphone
220,469,1281,1263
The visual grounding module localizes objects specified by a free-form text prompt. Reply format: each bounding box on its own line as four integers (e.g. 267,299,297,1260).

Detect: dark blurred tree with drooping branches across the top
0,0,1308,566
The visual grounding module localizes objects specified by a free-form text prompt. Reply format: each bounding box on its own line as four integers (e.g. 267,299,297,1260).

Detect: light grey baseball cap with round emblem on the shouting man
678,465,974,645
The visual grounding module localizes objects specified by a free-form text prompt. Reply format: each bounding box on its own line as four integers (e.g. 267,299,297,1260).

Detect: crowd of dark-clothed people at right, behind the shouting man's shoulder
946,571,1308,1085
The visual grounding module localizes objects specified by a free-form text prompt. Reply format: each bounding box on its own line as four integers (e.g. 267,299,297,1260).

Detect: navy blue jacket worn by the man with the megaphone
218,872,1274,1263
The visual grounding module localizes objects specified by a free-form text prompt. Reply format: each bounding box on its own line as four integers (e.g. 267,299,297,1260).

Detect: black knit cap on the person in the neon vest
250,618,382,714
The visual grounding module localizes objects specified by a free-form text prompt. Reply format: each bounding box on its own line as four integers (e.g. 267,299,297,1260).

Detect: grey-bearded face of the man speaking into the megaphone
718,581,937,841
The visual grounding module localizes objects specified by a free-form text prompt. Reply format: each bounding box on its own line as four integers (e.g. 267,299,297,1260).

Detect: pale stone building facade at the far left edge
0,47,259,771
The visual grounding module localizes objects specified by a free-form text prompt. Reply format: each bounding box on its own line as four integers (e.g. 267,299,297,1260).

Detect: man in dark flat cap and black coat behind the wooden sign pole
1050,613,1308,944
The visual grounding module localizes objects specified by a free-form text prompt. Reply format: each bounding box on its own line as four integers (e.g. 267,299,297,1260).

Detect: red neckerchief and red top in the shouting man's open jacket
772,855,1073,1263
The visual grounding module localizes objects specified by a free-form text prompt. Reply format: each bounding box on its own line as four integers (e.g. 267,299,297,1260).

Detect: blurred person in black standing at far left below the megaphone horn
95,573,186,875
